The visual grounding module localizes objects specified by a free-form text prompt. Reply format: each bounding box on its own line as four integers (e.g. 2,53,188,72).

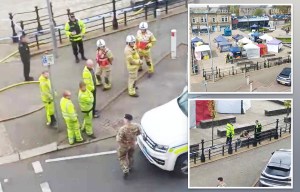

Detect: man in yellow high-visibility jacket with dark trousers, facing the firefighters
82,59,99,118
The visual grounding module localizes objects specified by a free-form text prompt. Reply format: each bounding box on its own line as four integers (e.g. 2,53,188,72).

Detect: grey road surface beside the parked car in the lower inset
189,137,291,187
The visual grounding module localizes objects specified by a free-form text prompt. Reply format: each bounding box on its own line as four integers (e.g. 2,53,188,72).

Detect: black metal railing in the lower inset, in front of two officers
189,119,291,165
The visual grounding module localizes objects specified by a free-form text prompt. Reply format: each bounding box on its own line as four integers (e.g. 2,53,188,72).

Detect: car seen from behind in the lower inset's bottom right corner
259,149,292,187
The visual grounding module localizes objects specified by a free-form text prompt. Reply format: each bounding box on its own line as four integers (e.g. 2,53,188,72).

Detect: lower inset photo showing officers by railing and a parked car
189,99,293,189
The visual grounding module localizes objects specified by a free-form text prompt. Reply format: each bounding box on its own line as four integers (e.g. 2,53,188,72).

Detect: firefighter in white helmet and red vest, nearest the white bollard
136,22,156,76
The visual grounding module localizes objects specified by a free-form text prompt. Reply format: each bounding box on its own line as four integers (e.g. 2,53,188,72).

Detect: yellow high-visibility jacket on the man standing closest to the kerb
60,97,78,121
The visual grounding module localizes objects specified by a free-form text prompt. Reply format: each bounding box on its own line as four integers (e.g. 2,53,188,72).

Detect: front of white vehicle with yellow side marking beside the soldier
137,87,188,176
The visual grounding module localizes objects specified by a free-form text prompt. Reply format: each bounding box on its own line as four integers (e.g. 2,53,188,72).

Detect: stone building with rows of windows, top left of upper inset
190,6,231,33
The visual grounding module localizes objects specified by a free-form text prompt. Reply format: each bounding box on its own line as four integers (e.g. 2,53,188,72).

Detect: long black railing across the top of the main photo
5,0,188,49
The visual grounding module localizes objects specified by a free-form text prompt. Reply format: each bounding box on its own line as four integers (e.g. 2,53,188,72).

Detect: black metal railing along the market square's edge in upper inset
202,55,292,80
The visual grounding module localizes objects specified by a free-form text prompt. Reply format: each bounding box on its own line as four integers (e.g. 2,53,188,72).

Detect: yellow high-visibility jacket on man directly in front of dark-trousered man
78,89,94,112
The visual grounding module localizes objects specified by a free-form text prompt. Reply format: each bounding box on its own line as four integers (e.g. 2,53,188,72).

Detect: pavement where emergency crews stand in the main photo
0,13,187,159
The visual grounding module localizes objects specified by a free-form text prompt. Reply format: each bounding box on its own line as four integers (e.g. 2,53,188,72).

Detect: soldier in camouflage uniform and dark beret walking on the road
116,114,140,179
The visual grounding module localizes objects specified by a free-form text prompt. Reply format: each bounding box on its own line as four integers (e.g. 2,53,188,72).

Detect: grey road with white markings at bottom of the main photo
0,138,188,192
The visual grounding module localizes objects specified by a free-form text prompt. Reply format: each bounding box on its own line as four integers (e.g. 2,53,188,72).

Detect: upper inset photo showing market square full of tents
188,4,293,94
